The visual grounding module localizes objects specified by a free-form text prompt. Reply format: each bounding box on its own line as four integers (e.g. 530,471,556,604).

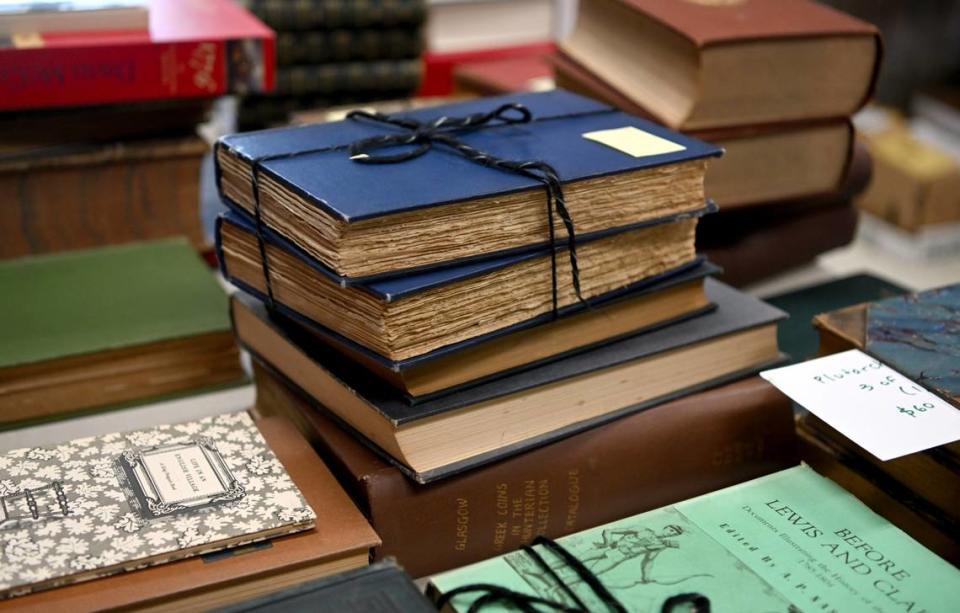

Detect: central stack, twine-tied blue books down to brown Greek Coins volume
216,91,792,575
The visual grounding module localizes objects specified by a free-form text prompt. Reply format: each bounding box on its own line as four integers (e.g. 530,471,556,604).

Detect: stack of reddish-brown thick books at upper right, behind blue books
555,0,880,280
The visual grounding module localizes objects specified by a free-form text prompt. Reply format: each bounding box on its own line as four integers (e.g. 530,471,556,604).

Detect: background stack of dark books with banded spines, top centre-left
238,0,427,128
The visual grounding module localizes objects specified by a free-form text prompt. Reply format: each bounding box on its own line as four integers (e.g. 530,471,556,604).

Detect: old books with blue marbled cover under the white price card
798,285,960,564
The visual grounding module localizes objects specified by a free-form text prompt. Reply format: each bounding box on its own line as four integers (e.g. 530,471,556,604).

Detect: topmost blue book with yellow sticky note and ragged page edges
216,90,721,284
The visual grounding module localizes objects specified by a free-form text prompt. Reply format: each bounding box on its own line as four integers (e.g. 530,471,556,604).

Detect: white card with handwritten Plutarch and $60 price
760,349,960,461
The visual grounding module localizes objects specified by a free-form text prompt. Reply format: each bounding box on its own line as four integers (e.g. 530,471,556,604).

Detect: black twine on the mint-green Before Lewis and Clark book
437,536,710,613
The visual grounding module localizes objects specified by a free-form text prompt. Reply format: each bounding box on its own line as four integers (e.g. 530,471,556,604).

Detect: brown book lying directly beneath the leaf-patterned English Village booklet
0,417,380,613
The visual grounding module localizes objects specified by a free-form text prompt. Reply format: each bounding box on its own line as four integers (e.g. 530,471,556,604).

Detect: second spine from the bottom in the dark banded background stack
277,59,421,96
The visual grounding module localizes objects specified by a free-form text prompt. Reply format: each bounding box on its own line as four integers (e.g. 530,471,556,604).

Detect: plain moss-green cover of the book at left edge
0,239,230,368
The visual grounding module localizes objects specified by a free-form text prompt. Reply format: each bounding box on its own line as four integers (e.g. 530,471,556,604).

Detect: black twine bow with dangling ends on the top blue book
347,103,589,317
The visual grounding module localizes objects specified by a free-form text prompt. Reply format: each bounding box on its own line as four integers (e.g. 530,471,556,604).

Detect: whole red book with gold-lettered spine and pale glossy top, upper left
0,0,274,110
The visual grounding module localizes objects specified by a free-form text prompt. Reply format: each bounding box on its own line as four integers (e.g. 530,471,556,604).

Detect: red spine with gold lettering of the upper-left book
0,38,274,110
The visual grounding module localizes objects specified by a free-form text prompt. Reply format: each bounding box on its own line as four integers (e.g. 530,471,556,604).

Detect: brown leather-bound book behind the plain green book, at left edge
0,136,208,258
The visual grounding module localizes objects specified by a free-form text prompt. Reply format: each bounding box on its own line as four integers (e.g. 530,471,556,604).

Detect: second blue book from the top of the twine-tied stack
216,207,710,364
